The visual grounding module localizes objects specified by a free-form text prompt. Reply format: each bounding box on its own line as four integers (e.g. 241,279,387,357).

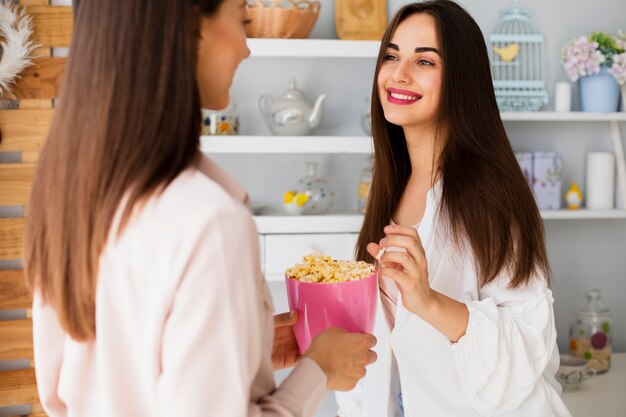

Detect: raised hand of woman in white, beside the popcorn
367,225,433,318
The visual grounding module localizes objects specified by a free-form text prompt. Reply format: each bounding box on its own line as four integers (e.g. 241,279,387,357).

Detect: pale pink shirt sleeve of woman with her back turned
157,207,326,416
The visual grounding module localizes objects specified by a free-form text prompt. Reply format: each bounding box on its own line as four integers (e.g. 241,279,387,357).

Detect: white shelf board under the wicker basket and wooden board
248,38,380,58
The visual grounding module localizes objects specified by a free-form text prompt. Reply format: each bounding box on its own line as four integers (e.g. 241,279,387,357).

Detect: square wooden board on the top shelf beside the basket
335,0,387,40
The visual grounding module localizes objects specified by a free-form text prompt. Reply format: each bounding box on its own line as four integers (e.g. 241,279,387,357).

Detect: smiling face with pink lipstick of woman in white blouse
377,13,443,129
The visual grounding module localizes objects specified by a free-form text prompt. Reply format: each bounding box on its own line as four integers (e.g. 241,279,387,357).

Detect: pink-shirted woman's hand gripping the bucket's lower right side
304,329,376,391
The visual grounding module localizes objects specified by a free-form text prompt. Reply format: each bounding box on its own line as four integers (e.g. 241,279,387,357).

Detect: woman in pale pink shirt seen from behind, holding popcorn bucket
25,0,375,417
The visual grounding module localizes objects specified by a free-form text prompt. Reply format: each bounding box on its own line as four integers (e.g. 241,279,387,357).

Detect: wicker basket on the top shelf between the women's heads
246,0,321,38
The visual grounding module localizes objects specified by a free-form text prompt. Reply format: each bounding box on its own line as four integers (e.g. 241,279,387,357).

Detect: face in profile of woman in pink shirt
196,0,250,110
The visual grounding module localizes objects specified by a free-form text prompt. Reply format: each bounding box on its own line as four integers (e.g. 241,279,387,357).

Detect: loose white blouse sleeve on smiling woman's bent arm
451,264,556,416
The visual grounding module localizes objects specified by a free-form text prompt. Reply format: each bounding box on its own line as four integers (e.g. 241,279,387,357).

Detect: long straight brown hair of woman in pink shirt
24,0,222,341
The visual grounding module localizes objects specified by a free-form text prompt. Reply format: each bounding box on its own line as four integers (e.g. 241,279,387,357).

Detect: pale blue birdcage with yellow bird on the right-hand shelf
489,0,548,112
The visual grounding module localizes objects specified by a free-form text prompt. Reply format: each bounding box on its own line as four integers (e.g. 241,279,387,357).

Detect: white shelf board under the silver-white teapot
200,135,373,154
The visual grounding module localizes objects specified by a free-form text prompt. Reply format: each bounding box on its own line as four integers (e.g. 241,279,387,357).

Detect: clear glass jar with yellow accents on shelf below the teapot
283,162,335,215
